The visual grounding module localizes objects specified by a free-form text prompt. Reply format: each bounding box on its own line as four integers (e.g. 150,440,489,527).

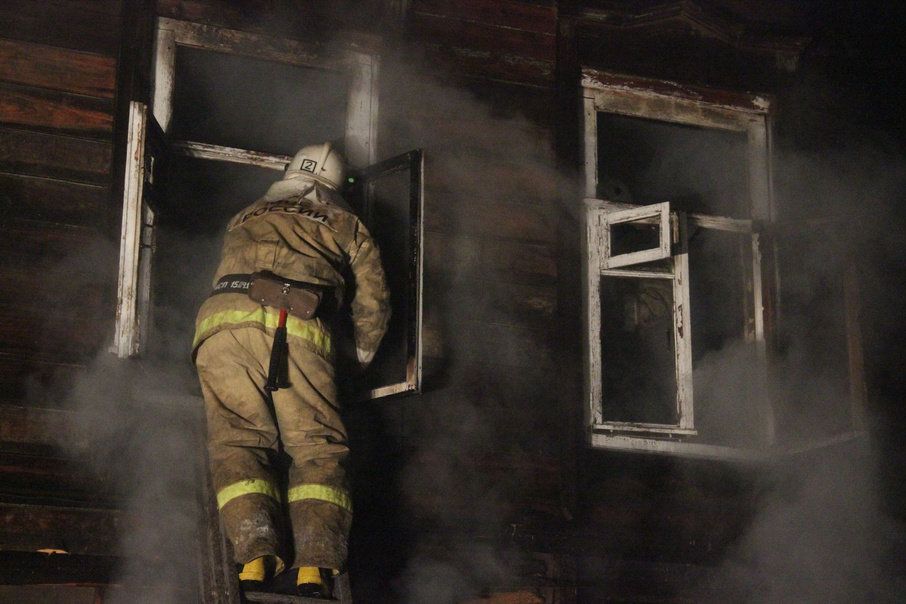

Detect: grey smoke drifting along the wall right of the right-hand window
680,124,906,602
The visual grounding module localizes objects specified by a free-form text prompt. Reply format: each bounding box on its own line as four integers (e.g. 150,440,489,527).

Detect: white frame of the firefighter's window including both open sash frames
111,17,424,399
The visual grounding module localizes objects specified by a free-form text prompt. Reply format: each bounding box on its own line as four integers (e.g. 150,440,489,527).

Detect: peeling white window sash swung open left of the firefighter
111,101,167,358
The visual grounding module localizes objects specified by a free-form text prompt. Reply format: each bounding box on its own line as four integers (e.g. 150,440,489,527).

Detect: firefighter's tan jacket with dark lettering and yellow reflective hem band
192,178,390,365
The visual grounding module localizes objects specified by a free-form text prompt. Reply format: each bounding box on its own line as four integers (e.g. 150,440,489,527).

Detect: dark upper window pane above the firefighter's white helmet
168,46,348,155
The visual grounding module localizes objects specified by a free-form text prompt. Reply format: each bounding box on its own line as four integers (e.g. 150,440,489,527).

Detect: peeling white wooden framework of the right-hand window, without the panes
581,68,775,459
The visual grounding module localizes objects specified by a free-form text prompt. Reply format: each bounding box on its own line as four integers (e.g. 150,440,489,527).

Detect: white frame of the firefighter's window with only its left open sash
111,17,380,358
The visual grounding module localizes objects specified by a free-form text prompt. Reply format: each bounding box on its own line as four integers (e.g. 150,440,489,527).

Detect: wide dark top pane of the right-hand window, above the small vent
597,113,749,218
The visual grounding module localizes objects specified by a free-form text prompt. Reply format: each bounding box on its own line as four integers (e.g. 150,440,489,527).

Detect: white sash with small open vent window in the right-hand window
585,199,696,439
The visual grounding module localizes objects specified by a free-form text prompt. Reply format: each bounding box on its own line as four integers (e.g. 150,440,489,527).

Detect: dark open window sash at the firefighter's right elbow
352,149,424,400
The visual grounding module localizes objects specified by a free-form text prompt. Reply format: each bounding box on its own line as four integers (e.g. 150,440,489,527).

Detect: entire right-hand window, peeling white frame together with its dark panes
582,69,864,459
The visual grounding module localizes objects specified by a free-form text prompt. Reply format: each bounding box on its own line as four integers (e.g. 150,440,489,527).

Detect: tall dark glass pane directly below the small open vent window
601,276,677,425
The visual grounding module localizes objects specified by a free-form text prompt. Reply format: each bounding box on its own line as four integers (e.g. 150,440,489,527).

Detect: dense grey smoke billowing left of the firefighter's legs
56,354,207,603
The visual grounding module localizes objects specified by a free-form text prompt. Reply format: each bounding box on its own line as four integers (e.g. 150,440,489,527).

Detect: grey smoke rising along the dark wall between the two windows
360,57,563,604
